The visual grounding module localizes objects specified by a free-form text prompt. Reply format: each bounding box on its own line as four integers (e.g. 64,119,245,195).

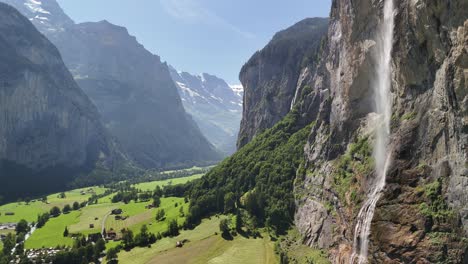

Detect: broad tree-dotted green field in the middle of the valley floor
25,197,188,249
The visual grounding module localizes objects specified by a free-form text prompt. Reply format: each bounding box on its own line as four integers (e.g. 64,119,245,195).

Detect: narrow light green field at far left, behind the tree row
0,187,105,223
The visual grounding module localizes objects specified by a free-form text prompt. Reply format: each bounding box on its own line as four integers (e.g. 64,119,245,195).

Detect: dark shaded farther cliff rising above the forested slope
237,18,328,148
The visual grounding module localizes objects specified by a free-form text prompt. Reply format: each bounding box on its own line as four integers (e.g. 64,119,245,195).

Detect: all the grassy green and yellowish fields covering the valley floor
0,171,278,264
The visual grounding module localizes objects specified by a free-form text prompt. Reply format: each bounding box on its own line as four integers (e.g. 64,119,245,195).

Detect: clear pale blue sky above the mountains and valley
58,0,331,84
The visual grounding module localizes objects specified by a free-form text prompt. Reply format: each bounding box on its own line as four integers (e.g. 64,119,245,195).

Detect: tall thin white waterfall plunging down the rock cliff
350,0,394,264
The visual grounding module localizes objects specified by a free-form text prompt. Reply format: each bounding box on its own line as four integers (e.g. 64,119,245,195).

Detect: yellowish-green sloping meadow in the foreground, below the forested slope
119,216,278,264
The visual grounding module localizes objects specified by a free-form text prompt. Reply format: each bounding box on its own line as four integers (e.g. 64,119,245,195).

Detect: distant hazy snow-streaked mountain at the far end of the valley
170,67,242,155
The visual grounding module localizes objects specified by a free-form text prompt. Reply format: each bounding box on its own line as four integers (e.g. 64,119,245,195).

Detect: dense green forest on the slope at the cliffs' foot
187,110,313,232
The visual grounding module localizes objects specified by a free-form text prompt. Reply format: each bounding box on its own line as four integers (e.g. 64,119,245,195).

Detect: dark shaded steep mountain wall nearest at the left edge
0,3,125,199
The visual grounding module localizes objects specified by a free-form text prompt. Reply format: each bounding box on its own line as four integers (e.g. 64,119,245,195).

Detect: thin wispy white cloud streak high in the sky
159,0,255,39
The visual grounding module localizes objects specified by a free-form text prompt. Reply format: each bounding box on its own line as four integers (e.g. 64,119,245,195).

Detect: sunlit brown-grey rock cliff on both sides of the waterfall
295,0,468,263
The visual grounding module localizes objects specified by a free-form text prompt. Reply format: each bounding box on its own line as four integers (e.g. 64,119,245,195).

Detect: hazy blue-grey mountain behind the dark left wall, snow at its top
1,0,220,169
